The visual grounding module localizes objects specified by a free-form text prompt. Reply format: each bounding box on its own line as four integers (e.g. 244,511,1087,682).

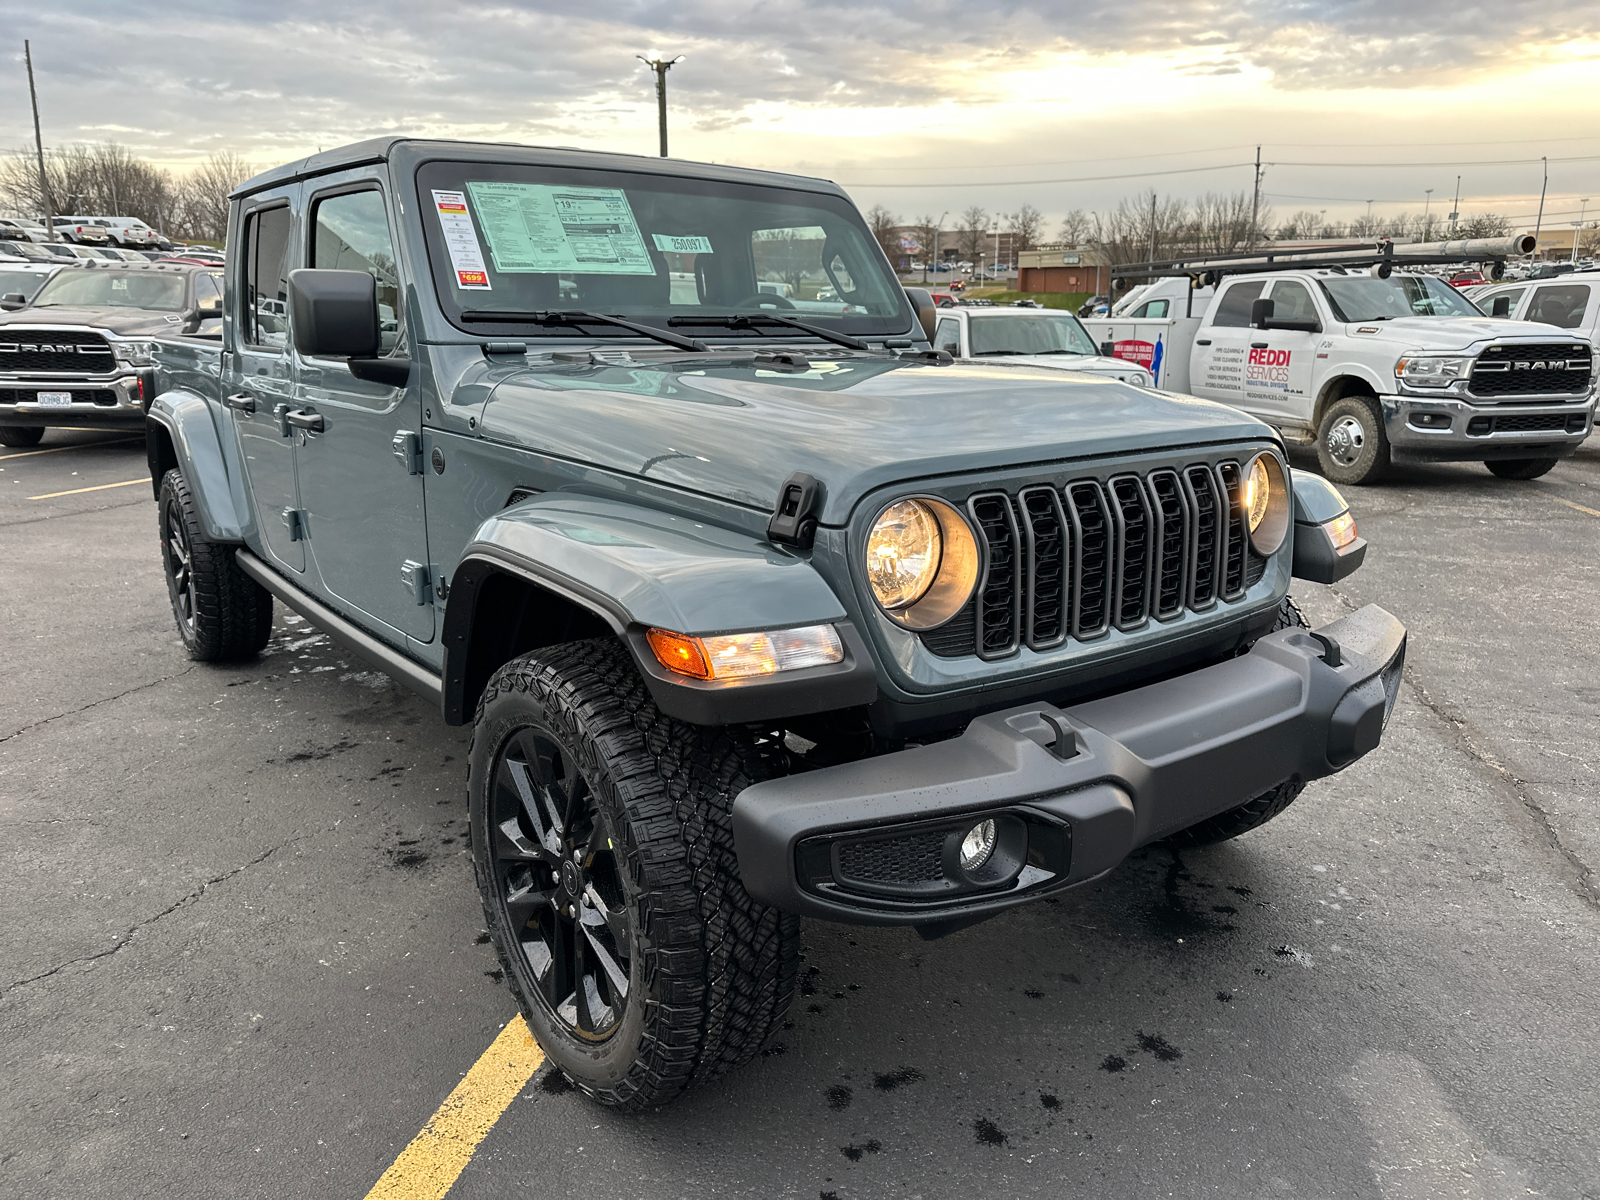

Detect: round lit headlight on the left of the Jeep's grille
866,498,978,629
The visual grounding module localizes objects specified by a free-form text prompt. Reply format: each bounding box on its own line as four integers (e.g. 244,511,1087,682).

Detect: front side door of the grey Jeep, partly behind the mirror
296,171,434,642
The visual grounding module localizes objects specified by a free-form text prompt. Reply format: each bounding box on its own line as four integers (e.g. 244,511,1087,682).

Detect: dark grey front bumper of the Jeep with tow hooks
733,605,1405,925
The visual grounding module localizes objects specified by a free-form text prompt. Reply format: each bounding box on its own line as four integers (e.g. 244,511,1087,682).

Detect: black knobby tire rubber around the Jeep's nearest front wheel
467,638,800,1109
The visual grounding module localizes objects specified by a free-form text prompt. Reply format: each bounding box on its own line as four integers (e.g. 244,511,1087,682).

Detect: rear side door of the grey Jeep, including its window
232,186,306,571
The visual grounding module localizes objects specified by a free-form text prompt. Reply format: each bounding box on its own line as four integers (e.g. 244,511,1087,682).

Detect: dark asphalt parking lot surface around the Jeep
0,430,1600,1200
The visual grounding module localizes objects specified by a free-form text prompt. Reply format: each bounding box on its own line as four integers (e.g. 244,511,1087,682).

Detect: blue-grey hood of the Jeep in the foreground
478,357,1272,525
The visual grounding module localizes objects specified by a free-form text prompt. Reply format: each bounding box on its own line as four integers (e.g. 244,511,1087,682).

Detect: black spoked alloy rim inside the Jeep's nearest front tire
490,726,634,1042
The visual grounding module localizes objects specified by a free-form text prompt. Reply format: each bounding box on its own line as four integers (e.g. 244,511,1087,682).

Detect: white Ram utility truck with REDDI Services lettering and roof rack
1086,238,1597,483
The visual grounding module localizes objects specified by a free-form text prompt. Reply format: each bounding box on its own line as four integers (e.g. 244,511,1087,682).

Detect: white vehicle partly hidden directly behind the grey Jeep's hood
933,307,1155,387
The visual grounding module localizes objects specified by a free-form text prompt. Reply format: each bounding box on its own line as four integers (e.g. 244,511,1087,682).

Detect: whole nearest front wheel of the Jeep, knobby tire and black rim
467,638,800,1109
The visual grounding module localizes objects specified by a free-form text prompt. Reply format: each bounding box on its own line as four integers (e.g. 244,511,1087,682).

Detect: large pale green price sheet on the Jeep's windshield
467,179,656,275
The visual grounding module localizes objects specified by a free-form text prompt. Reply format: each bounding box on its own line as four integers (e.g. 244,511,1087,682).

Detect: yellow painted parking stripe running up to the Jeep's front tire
366,1014,544,1200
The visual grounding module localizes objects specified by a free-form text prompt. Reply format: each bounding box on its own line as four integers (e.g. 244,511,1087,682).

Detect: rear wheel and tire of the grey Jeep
155,467,272,662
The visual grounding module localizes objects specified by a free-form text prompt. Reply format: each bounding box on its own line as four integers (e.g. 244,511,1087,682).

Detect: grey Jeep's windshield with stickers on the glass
418,162,910,338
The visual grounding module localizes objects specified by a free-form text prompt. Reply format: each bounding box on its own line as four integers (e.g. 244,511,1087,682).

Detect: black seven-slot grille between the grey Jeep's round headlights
920,461,1267,659
